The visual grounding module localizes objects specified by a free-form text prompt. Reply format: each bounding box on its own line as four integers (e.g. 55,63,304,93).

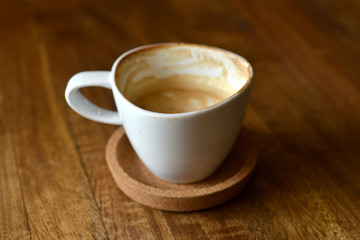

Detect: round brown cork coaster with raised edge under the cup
106,127,257,212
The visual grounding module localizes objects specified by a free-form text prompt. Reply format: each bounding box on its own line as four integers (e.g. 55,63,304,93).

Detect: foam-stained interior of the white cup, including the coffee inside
115,43,252,113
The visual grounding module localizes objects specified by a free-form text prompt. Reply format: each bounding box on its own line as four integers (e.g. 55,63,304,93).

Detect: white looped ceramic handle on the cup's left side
65,71,122,125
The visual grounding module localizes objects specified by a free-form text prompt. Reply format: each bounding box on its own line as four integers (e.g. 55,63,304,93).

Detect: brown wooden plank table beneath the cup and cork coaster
0,0,360,239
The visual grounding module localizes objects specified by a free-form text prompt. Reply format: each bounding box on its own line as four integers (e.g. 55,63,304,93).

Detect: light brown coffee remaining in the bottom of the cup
127,75,237,113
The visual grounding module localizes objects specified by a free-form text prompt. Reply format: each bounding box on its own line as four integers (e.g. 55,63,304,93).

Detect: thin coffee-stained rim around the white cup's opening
110,42,254,119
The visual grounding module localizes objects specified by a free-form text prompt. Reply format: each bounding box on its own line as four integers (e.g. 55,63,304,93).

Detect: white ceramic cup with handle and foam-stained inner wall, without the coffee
65,43,253,183
